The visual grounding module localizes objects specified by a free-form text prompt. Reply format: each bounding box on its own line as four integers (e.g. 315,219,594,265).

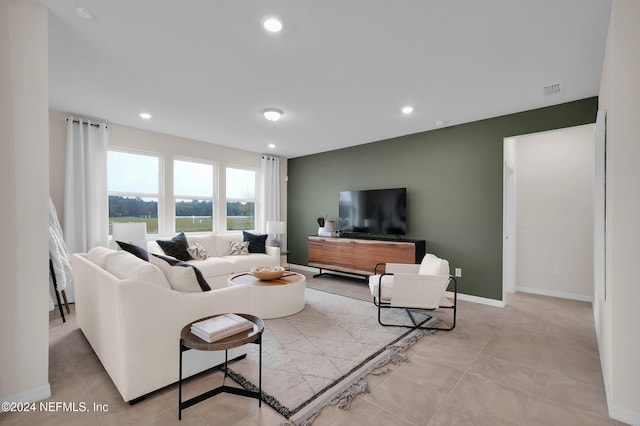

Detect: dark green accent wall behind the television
287,97,598,300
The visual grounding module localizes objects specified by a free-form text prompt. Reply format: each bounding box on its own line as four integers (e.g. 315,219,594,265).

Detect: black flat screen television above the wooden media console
338,188,407,235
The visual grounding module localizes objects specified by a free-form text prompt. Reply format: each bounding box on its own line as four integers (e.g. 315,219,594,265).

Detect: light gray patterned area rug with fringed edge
222,288,438,425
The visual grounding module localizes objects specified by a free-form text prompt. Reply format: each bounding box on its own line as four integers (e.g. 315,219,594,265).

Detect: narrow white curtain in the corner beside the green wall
258,155,280,232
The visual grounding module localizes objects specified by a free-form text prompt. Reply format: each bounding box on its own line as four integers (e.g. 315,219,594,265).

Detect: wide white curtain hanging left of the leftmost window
64,117,109,253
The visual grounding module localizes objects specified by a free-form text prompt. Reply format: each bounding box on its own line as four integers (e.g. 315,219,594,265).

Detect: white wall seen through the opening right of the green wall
511,124,594,301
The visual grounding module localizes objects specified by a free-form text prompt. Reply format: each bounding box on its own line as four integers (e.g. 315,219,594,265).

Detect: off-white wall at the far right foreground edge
594,0,640,425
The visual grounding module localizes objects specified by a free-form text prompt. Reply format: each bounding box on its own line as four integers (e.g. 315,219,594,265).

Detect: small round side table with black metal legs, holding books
178,314,264,420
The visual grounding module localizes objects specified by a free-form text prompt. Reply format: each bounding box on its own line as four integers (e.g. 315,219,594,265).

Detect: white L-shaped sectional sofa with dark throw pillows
71,235,279,402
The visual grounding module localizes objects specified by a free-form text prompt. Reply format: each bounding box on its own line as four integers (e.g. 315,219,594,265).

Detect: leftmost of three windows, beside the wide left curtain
107,150,160,235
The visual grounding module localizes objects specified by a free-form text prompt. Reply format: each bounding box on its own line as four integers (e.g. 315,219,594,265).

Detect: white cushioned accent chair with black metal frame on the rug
369,253,458,331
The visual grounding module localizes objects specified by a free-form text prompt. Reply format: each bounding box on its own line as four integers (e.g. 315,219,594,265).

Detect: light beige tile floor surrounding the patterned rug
0,274,622,426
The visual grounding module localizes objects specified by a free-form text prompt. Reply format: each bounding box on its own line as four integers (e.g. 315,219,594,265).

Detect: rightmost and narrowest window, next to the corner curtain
227,167,256,231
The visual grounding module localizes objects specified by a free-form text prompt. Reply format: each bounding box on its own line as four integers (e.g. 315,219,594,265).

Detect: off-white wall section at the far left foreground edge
0,0,51,402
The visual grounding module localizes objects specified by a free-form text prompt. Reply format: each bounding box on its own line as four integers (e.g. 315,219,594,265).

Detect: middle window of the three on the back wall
173,160,214,232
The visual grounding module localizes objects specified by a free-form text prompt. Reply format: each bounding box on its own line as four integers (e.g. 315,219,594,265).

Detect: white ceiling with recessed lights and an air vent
40,0,610,158
